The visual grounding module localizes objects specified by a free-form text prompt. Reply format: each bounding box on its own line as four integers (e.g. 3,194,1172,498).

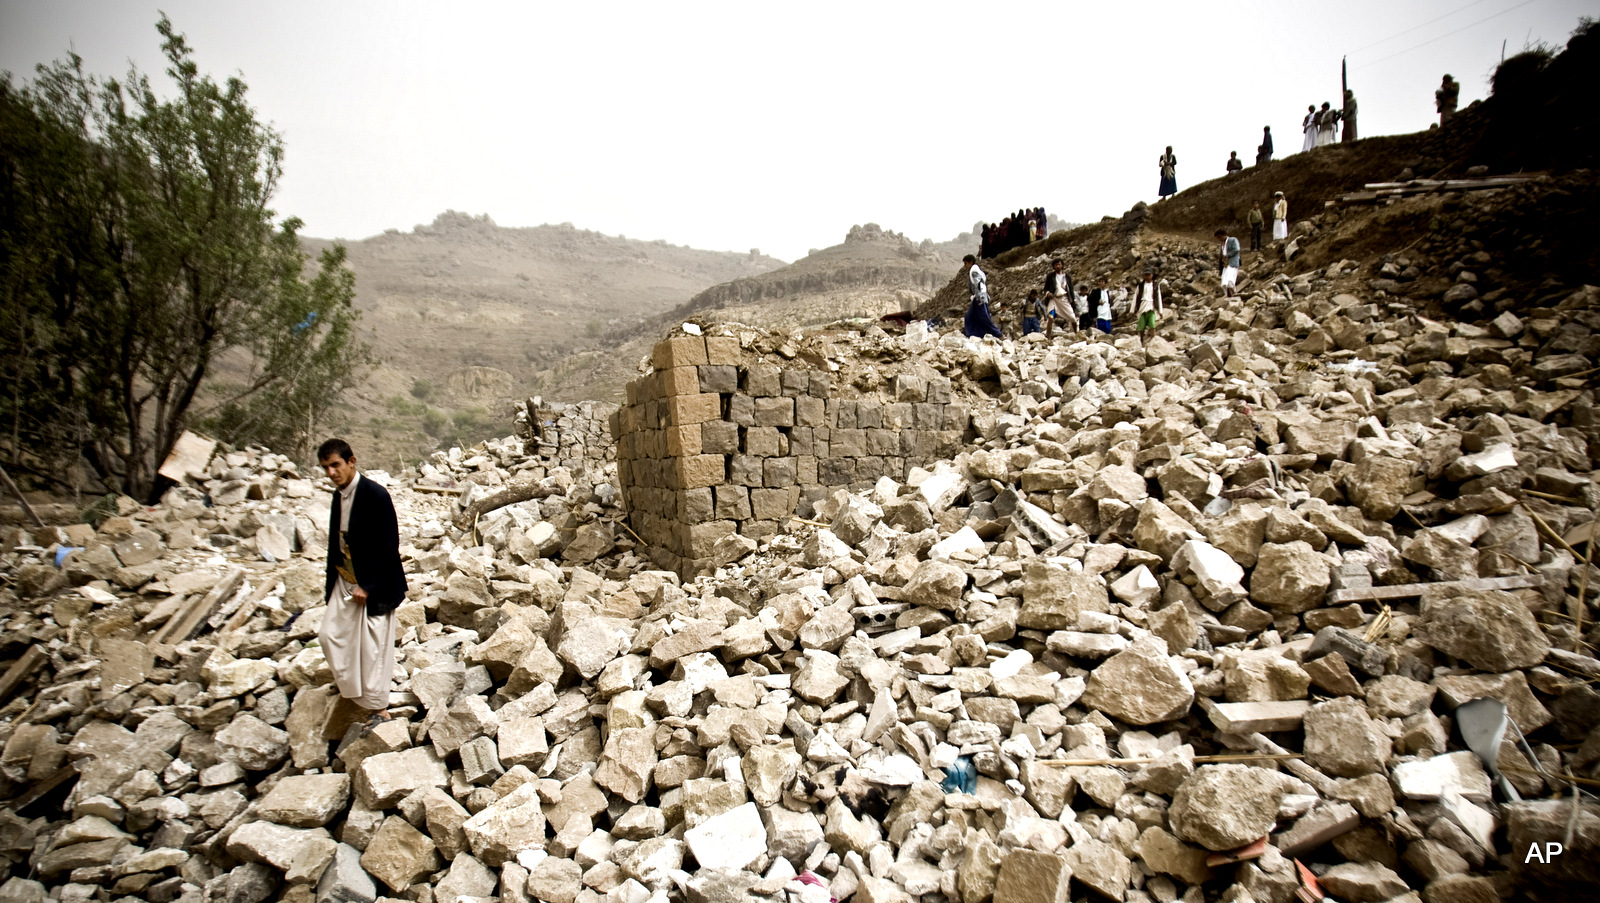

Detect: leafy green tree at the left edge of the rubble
0,16,365,496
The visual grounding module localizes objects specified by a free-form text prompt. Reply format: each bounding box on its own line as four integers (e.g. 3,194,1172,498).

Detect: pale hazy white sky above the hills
0,0,1600,259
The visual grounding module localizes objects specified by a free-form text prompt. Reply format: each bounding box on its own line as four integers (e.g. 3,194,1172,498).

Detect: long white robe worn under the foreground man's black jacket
317,474,395,711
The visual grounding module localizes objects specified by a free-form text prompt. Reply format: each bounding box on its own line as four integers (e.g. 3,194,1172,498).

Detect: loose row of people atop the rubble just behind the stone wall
962,257,1177,352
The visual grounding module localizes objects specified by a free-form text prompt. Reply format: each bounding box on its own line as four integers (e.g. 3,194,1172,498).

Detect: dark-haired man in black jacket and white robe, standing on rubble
317,439,406,725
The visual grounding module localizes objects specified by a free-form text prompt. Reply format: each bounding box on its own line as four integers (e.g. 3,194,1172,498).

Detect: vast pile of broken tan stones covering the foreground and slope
0,254,1600,903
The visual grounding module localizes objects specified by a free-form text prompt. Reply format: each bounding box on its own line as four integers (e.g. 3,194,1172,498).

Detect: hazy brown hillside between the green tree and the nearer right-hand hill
304,210,784,460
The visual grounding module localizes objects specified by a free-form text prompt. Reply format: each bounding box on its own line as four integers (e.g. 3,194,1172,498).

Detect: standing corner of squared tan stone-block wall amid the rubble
611,330,971,575
